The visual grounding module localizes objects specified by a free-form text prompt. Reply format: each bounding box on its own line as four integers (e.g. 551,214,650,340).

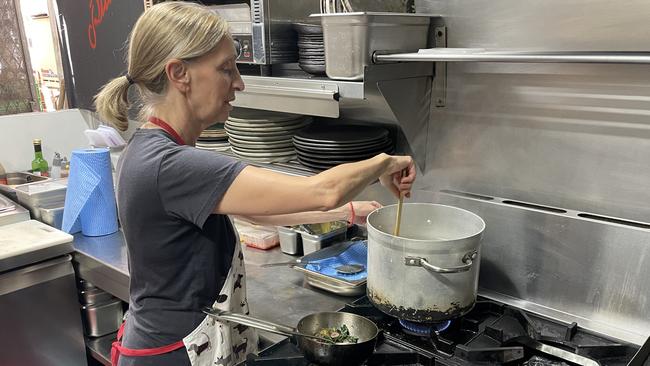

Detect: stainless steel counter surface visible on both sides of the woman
74,231,353,342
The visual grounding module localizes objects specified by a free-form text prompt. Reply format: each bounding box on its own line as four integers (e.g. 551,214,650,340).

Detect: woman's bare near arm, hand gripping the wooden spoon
214,154,415,216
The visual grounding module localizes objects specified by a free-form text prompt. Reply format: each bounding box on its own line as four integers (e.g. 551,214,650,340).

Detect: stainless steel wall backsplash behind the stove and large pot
352,0,650,343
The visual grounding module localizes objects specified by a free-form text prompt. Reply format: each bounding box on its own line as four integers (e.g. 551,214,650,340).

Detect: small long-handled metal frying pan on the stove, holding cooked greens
204,308,379,366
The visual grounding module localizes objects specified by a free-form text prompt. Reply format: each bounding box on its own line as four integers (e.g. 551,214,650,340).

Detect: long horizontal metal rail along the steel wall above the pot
373,48,650,64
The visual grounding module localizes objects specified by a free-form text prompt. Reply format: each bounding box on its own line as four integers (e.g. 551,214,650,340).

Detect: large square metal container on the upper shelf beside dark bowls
311,12,431,80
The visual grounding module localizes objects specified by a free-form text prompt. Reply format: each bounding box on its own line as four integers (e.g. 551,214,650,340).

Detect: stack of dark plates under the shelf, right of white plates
293,121,394,170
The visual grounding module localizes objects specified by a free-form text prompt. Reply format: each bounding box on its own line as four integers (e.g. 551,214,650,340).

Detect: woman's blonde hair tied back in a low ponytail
95,1,229,131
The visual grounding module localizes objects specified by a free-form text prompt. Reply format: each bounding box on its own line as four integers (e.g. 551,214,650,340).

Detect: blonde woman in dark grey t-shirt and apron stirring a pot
96,2,415,366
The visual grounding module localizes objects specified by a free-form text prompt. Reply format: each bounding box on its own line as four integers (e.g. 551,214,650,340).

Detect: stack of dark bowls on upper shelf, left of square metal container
294,23,325,75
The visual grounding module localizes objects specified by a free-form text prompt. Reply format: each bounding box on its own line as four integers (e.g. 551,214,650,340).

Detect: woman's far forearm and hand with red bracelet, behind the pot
236,201,381,226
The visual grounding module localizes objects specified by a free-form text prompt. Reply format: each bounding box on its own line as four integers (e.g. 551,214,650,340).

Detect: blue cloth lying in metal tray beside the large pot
305,241,368,281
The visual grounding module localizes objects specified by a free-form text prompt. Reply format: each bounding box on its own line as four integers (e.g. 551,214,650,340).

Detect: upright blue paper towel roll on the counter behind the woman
61,149,118,236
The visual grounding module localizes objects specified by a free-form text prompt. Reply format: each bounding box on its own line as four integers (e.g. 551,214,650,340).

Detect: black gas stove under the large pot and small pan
243,297,650,366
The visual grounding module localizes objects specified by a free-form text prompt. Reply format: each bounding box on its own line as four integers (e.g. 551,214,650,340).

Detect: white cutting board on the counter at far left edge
0,220,73,260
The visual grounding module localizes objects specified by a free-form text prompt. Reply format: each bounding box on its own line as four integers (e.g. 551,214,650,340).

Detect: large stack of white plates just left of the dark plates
225,109,309,163
